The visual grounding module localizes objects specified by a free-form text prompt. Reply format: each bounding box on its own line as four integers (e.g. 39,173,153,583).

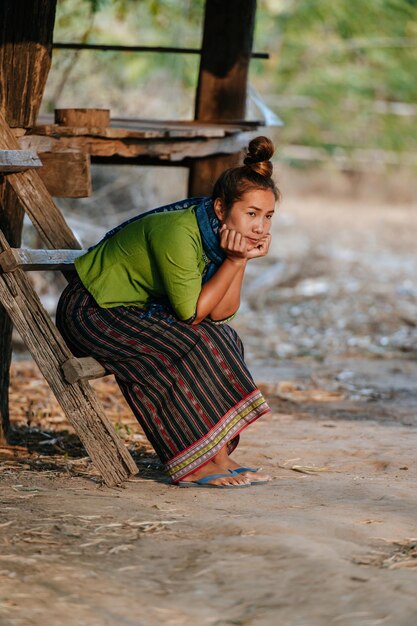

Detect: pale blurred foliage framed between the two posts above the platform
43,0,204,119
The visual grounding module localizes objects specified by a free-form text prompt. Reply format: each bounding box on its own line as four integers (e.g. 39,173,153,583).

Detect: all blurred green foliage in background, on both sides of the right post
45,0,417,153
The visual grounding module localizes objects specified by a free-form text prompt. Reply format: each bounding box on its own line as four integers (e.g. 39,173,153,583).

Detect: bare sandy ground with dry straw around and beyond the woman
0,183,417,626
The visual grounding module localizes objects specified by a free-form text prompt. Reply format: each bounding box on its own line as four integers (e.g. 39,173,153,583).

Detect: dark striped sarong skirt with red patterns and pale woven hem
56,278,269,482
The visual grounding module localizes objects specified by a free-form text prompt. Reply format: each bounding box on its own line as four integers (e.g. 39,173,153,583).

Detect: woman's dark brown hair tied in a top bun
212,136,281,213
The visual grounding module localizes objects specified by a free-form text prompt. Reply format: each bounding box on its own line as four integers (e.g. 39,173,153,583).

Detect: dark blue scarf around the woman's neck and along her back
89,196,225,282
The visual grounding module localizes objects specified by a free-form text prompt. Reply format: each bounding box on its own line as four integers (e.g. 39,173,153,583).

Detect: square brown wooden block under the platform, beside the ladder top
39,152,93,198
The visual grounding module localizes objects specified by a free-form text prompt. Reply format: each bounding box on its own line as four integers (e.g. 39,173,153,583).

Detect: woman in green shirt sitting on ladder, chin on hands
57,137,279,488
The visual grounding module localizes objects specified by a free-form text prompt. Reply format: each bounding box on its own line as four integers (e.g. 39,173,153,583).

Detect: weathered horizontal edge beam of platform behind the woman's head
14,116,260,165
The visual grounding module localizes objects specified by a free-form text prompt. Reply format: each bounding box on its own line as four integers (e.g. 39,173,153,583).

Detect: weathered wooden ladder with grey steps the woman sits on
0,114,138,486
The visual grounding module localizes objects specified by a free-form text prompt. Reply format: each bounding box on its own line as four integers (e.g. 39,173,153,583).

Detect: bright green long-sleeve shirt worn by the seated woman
75,207,206,321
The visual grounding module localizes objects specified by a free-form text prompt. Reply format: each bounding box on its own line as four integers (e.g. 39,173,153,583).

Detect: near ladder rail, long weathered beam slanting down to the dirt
0,232,138,486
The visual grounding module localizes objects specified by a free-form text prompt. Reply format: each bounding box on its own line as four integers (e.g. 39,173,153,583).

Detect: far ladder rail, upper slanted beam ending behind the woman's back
0,113,81,249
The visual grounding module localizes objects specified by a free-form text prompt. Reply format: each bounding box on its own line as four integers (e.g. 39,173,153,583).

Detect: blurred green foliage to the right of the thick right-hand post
264,0,417,152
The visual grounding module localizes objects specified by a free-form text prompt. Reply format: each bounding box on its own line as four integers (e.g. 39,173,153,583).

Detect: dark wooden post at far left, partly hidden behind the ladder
0,0,57,442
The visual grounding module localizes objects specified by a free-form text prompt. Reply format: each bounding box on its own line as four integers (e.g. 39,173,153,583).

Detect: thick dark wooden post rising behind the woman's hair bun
189,0,256,196
